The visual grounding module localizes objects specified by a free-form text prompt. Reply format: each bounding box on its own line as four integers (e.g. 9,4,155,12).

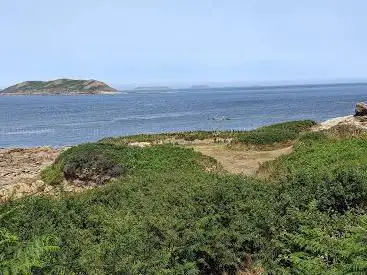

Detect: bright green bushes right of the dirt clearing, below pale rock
261,129,367,176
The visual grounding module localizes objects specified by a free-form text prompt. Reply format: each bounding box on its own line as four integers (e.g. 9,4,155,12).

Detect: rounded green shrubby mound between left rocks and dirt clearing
41,143,219,185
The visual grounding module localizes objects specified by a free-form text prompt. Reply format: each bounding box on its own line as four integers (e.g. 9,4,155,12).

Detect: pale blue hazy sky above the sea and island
0,0,367,87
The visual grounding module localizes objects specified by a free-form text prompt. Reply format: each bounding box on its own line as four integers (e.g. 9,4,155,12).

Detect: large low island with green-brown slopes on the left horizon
0,79,118,95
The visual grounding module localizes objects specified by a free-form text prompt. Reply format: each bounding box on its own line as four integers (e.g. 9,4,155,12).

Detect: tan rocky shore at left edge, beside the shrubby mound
0,147,61,201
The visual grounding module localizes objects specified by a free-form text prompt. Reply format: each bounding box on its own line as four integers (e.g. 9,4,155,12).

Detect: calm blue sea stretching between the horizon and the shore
0,84,367,147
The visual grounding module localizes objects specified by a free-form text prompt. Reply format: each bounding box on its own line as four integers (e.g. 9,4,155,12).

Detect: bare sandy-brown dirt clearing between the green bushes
189,143,292,175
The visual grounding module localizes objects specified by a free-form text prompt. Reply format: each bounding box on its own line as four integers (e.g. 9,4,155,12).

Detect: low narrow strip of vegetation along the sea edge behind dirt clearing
101,120,316,146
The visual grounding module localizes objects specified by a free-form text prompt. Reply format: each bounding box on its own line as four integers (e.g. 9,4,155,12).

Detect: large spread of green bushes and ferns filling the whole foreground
0,123,367,274
